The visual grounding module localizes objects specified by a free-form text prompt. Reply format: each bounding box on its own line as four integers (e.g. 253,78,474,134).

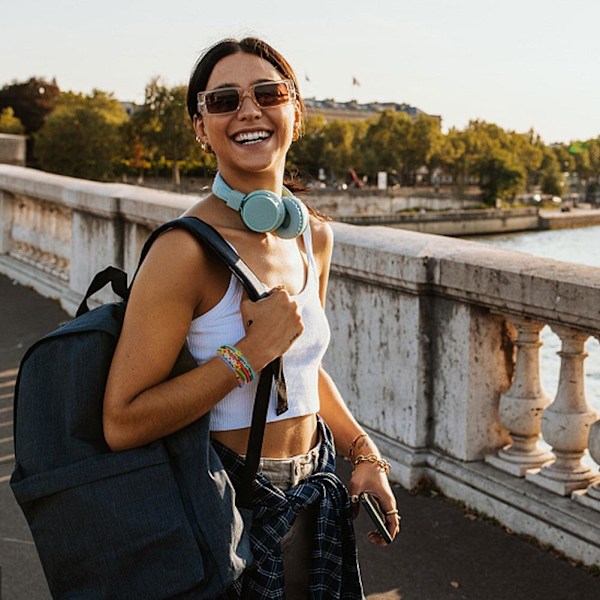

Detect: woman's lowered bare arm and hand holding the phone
313,222,400,546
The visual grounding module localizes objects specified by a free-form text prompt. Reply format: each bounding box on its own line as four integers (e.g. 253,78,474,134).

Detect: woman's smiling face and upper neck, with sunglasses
193,52,302,193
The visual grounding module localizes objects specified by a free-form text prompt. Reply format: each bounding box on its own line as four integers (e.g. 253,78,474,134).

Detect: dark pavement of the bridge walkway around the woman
0,276,600,600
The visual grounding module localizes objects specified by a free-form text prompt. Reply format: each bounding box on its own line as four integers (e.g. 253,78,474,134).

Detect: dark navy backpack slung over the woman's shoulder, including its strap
10,217,279,600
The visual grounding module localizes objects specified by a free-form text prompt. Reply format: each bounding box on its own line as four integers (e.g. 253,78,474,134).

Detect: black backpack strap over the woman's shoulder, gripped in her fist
142,217,285,508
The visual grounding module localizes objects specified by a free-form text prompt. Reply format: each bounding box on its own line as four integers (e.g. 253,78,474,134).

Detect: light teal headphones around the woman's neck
212,173,309,239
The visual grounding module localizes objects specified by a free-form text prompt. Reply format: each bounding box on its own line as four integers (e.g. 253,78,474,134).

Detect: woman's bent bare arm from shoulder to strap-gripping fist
103,231,302,450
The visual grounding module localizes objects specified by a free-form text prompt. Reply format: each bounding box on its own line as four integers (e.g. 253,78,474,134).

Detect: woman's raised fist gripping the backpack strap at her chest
236,287,304,370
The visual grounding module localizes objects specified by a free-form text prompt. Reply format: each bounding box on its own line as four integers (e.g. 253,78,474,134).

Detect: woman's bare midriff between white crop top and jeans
211,414,317,458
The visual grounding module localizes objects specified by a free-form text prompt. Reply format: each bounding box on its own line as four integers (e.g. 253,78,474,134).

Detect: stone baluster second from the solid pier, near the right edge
525,326,597,496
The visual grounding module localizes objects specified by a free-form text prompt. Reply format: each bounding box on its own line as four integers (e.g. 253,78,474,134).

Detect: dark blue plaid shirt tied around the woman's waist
213,418,364,600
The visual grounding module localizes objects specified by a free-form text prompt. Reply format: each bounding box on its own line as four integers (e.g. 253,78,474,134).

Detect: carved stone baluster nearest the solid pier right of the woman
485,318,554,477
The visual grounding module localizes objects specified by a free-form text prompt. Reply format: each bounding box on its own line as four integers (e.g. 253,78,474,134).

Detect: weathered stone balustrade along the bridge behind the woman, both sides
0,166,600,565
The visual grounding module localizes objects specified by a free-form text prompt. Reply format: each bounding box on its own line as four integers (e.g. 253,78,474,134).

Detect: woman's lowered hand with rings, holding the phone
348,462,400,547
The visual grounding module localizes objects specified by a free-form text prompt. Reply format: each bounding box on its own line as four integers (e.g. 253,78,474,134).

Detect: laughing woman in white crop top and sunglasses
104,38,399,598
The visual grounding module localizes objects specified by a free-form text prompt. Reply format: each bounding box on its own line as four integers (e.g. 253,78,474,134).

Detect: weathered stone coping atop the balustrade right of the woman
333,223,600,335
